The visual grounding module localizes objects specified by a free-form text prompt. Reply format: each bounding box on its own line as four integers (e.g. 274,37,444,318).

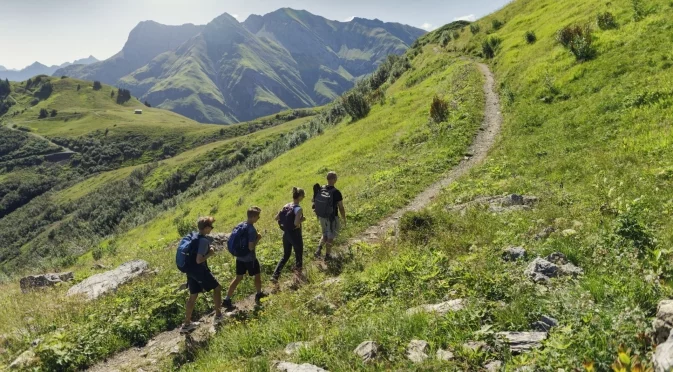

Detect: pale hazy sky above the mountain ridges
0,0,509,68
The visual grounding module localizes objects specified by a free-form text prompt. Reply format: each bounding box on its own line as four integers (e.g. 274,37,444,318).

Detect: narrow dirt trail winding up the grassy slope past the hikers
89,63,502,372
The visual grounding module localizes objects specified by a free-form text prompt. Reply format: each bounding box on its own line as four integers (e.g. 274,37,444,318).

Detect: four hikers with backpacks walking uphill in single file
176,172,346,333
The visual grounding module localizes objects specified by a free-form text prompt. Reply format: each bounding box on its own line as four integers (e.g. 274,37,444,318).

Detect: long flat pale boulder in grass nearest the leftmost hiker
67,260,149,300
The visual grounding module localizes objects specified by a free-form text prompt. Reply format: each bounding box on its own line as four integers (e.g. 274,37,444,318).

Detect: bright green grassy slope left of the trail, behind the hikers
0,22,483,368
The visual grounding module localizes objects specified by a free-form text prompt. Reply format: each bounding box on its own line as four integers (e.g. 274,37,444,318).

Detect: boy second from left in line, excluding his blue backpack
223,207,266,309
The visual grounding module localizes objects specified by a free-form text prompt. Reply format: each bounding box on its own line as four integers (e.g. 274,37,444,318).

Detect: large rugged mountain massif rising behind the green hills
54,8,425,124
